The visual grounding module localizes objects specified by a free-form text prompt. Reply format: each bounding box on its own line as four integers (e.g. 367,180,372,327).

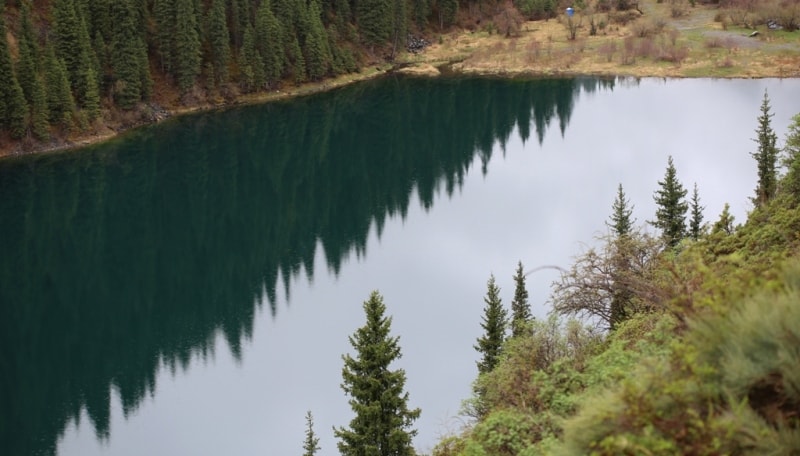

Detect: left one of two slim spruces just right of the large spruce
475,274,508,374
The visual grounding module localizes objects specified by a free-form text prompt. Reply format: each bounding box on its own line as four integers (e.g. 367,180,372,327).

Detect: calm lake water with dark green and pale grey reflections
0,77,800,456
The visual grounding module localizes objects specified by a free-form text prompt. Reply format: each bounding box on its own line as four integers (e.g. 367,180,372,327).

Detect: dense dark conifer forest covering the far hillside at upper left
0,0,482,148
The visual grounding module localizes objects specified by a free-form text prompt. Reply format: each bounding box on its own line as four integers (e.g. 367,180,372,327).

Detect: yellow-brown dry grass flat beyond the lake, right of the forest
406,0,800,78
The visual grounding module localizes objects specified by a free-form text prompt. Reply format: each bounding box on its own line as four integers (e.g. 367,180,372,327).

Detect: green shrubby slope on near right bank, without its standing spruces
434,157,800,456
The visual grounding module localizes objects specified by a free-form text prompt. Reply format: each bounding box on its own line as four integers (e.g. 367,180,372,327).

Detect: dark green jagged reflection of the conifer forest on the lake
0,75,613,455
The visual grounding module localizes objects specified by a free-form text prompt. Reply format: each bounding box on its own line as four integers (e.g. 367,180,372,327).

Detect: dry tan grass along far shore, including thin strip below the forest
0,0,800,158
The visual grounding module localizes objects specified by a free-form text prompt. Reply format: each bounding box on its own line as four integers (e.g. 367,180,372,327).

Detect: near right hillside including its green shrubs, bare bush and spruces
433,106,800,456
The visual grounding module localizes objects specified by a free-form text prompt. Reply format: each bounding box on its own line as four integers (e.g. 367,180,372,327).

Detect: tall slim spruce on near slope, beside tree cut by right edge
750,90,778,206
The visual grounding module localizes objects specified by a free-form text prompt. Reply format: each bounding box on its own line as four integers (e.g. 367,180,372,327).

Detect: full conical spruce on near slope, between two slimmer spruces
650,156,689,247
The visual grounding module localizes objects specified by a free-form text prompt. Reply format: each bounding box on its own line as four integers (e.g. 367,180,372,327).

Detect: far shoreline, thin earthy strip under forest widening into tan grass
0,5,800,161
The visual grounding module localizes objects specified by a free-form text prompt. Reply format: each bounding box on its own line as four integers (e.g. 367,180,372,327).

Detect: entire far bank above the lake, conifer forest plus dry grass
0,0,800,155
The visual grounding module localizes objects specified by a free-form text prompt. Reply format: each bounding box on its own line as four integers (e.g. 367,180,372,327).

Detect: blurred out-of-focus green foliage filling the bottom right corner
564,264,800,455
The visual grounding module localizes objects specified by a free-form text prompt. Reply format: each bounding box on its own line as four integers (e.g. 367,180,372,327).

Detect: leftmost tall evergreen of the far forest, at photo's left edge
0,4,28,139
